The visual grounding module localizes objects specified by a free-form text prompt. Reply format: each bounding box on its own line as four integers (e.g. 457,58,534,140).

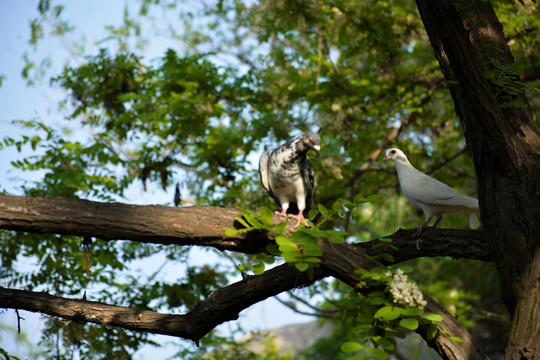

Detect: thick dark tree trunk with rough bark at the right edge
416,0,540,359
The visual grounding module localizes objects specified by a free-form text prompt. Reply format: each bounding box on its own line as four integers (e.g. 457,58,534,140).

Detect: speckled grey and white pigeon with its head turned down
259,132,321,226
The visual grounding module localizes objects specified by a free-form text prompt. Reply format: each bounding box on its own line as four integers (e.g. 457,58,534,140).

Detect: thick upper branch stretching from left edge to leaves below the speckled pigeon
0,195,272,254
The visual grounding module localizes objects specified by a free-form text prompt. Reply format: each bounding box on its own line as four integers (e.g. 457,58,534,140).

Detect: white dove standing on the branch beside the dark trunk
384,149,480,238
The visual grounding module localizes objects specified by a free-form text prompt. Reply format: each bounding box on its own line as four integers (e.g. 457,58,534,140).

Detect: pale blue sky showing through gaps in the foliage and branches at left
0,0,312,359
